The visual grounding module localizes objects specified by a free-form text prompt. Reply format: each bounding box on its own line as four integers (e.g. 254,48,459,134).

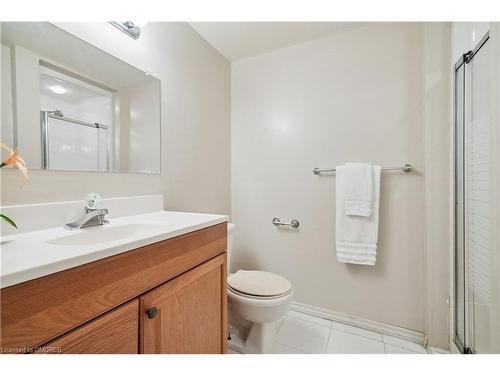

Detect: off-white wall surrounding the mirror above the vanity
2,22,230,213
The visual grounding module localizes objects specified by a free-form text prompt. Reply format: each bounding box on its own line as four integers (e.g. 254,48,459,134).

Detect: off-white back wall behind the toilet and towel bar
231,23,449,346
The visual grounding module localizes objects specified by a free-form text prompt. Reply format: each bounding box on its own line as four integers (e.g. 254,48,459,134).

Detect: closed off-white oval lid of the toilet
227,270,292,297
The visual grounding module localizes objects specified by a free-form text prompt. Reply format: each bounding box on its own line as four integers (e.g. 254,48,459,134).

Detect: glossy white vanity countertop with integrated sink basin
0,211,228,288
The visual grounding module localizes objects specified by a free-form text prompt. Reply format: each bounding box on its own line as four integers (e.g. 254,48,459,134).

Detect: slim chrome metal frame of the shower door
452,32,490,354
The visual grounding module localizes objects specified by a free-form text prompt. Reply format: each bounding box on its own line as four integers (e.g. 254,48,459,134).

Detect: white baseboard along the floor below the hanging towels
290,301,427,346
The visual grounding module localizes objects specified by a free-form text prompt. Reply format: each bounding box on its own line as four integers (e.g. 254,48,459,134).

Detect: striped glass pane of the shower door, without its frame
466,33,494,353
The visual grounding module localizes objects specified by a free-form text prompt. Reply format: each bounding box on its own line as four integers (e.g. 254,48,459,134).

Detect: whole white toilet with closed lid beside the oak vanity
227,223,293,353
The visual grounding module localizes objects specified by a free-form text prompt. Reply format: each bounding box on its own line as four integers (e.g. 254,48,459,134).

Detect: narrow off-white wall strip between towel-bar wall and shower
423,22,453,348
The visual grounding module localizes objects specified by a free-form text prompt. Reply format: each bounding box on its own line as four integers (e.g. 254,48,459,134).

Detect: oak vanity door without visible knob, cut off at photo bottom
37,299,139,354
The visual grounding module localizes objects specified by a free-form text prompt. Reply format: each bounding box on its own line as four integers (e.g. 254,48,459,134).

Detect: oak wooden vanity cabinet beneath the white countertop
0,223,227,353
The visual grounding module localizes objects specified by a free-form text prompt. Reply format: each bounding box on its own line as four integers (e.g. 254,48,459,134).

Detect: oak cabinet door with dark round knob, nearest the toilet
140,253,226,353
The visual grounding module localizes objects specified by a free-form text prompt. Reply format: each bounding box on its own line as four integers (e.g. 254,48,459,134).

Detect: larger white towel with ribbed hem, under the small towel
335,166,380,266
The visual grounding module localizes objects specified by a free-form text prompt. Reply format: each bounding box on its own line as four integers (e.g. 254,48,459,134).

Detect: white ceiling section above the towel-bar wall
190,22,366,61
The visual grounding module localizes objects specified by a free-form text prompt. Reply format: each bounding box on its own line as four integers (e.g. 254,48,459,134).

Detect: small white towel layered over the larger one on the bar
337,163,373,216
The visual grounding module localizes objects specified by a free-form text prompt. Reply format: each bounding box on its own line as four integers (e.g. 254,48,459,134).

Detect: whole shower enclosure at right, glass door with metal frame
453,30,499,353
